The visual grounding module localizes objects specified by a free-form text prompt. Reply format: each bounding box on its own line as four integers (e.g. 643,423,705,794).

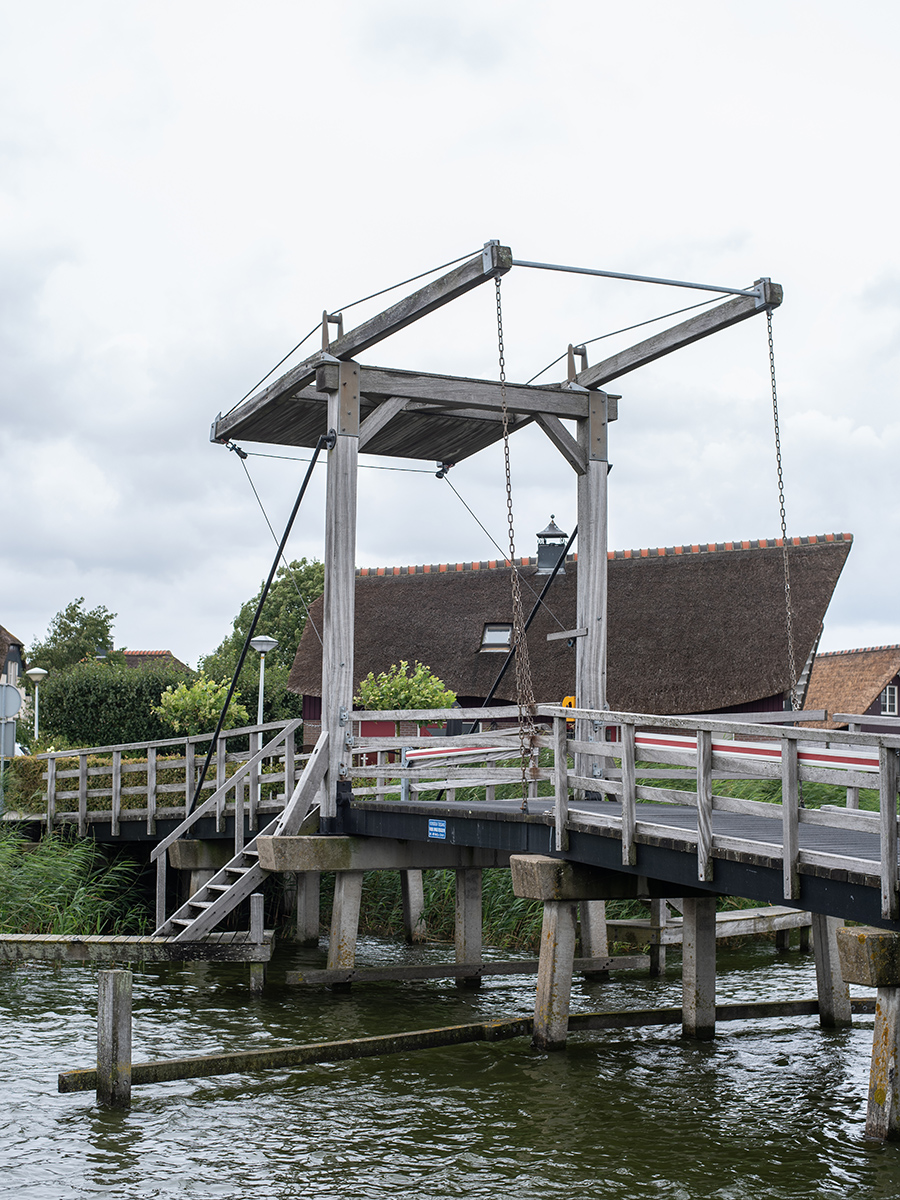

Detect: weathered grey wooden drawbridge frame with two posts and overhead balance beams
211,241,782,817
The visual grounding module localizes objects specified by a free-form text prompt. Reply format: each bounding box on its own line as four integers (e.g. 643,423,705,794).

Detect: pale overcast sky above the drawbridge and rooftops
0,0,900,662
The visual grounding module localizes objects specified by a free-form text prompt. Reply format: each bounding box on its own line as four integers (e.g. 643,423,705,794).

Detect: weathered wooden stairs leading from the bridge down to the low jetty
154,732,328,942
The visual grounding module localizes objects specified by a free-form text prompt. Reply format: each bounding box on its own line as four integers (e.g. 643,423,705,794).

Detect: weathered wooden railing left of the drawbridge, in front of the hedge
35,721,301,838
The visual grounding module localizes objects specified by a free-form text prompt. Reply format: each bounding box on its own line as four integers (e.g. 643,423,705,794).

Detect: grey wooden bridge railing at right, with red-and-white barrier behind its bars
538,706,900,919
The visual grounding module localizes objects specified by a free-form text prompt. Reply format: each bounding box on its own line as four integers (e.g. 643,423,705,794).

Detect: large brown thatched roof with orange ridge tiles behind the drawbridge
288,534,852,720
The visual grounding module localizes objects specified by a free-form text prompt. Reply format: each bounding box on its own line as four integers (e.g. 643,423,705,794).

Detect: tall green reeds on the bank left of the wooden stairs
0,826,152,935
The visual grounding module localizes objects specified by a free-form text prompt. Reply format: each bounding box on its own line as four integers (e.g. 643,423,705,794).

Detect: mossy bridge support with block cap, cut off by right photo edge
844,925,900,1141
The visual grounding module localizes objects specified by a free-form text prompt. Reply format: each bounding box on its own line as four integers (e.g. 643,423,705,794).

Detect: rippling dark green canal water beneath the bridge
0,938,900,1200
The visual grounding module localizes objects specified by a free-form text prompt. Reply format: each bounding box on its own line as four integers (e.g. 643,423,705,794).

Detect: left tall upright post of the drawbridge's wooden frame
320,362,359,820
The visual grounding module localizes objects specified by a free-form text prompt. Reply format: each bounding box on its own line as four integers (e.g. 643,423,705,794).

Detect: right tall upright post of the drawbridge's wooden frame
575,391,610,775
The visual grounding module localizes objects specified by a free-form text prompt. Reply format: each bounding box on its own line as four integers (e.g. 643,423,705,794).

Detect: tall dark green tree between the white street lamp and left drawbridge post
199,558,325,721
